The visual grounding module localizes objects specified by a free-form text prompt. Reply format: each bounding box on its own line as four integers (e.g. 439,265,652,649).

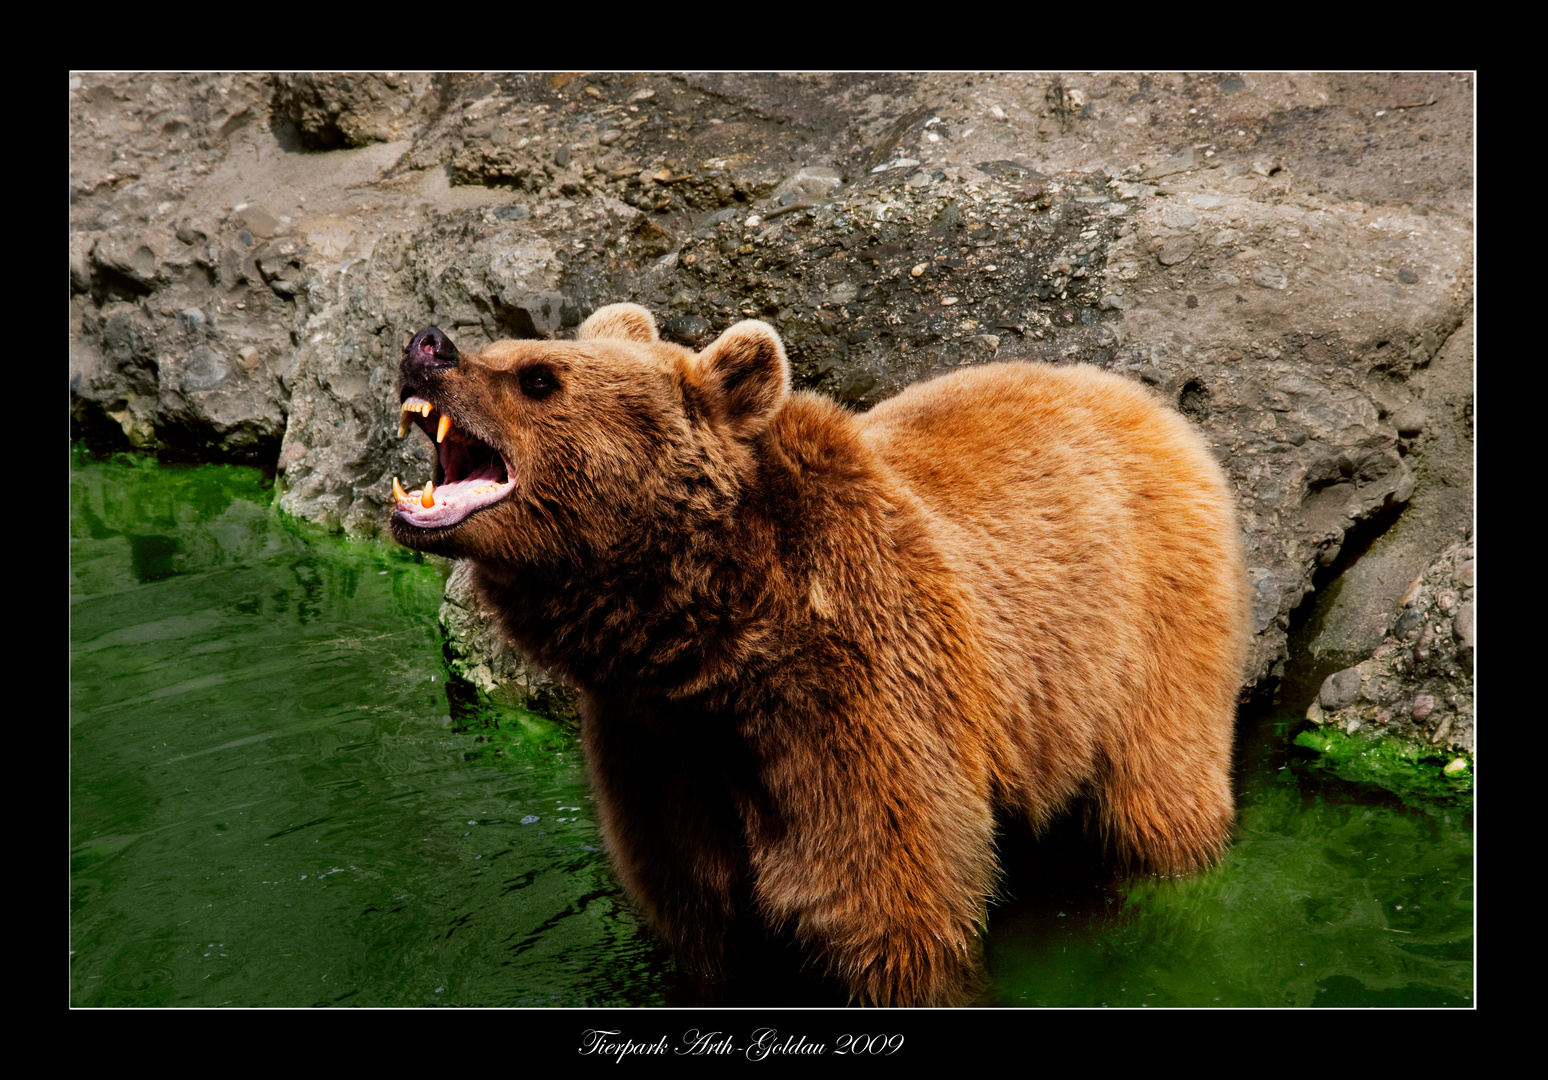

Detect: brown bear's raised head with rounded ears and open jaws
390,303,789,566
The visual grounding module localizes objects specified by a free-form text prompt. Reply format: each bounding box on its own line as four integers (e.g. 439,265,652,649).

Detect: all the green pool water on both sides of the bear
70,453,1472,1007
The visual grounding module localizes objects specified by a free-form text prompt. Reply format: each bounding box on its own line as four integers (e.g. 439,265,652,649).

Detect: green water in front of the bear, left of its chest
70,445,667,1006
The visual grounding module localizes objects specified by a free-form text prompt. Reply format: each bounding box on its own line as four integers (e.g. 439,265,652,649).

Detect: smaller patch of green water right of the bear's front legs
989,716,1474,1007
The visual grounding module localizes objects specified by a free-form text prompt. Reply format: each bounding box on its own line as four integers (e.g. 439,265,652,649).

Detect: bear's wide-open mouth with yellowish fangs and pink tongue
392,396,515,529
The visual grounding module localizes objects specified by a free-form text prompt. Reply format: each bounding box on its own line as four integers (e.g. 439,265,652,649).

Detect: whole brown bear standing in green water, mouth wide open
390,303,1248,1006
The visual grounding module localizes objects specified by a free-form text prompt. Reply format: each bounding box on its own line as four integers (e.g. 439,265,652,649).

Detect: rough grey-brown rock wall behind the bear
70,73,1474,746
